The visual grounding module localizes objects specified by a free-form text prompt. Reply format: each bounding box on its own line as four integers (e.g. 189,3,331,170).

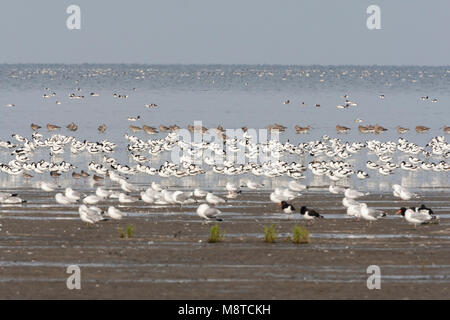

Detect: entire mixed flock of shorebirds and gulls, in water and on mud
0,89,450,231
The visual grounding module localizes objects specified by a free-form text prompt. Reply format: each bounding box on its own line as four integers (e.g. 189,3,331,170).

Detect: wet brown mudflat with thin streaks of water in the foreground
0,189,450,299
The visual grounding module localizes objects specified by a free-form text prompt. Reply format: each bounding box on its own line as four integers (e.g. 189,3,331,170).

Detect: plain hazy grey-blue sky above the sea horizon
0,0,450,66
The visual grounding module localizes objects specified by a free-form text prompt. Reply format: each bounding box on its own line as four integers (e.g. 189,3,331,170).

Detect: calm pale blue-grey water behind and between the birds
0,65,450,190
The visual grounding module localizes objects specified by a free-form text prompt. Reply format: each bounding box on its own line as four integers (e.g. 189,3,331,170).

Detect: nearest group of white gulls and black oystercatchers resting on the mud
0,172,439,227
